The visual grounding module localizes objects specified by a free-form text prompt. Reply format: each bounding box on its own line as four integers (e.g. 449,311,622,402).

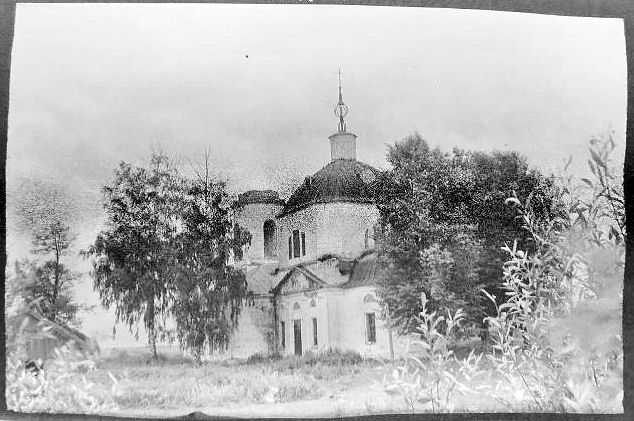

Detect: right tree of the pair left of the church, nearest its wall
172,151,250,361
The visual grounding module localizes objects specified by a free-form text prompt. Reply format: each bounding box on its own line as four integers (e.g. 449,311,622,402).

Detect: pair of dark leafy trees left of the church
85,149,250,362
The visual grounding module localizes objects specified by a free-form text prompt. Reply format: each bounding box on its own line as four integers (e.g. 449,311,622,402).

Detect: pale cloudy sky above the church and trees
7,4,627,348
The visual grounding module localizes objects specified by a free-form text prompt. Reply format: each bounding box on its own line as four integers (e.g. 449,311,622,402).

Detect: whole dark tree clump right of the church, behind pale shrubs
375,133,557,332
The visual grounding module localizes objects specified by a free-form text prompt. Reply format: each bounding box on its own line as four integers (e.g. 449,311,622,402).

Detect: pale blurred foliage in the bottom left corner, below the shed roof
6,347,119,414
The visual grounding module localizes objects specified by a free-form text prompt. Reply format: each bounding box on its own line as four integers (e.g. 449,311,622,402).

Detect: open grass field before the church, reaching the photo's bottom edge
87,348,405,417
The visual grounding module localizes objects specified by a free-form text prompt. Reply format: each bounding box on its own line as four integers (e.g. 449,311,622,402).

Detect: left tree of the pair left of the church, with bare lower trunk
85,152,181,359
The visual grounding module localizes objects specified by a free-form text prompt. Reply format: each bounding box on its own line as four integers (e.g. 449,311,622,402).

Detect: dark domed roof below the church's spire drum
280,159,378,216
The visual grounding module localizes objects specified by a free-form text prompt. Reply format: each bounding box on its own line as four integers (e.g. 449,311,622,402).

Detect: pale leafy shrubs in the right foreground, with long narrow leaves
386,135,625,412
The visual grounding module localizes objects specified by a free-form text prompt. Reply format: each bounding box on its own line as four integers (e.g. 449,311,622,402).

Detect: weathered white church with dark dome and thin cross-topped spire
232,81,402,358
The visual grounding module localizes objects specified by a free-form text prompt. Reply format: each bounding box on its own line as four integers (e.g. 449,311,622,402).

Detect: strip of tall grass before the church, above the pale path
85,350,373,410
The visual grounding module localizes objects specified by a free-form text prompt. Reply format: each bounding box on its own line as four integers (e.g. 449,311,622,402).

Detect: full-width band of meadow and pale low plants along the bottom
7,324,622,418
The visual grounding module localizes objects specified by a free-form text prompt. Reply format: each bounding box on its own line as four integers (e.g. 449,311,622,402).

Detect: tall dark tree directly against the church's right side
375,134,481,333
